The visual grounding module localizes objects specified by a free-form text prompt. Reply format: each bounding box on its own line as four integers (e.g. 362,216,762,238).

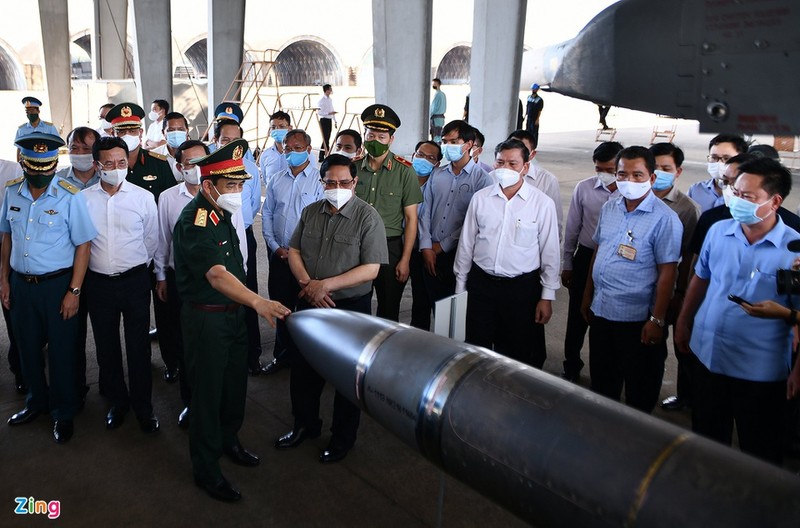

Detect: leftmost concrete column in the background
39,0,72,137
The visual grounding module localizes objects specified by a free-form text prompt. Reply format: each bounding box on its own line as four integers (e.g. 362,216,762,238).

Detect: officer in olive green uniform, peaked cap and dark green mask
356,104,422,321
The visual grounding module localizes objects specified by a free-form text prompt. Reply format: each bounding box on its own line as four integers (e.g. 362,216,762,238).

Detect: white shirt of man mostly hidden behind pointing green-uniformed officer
154,182,247,280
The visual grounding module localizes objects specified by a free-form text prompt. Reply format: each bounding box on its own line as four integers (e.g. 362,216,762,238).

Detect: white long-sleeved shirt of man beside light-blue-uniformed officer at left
81,180,158,275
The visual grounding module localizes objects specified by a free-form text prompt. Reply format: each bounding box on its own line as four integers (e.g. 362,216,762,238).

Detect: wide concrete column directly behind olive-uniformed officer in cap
372,0,433,155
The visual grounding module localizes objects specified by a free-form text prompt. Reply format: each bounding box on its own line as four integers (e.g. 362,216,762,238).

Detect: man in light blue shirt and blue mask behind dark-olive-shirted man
261,129,323,374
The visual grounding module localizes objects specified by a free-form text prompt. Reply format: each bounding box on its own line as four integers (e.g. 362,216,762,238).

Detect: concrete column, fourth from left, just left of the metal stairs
208,0,246,115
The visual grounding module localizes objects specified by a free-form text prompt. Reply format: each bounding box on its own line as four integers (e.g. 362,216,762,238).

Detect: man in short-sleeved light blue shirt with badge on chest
582,146,683,413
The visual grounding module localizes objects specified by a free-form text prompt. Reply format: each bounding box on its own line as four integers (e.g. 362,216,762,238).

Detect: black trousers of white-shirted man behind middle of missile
466,264,547,369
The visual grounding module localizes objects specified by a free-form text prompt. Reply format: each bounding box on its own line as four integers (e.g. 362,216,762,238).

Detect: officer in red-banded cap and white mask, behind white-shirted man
106,103,178,203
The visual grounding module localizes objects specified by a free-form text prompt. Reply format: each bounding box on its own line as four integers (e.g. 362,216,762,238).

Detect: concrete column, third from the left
132,0,172,112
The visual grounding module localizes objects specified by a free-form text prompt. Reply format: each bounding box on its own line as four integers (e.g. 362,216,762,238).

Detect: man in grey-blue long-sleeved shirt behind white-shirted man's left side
419,120,492,303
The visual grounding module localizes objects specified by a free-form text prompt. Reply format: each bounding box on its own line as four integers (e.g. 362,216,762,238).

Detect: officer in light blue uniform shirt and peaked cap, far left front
0,133,97,443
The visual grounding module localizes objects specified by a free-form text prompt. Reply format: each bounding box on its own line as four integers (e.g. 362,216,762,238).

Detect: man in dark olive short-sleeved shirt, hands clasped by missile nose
275,154,388,462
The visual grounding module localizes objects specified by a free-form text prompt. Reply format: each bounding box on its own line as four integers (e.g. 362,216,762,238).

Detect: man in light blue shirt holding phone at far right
675,158,800,464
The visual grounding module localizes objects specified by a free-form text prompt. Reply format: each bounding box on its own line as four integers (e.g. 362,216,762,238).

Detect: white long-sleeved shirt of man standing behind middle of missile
453,181,561,301
